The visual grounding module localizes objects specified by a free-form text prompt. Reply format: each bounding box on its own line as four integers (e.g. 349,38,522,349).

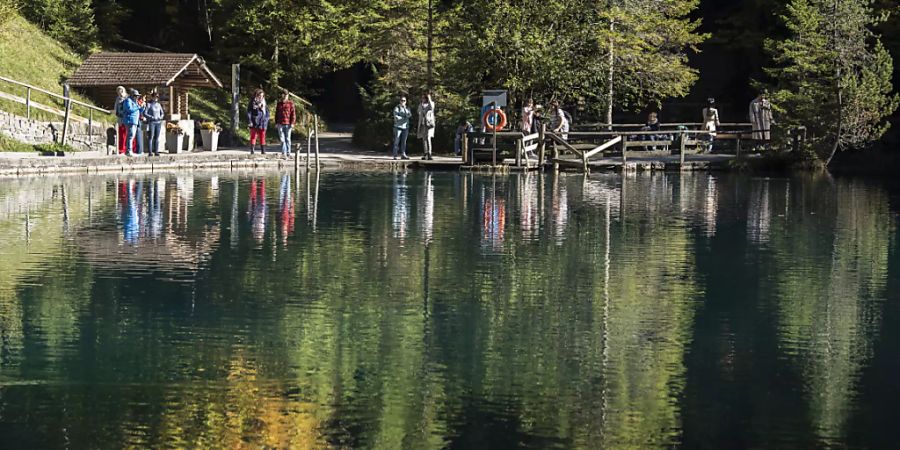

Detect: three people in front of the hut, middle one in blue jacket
114,86,165,156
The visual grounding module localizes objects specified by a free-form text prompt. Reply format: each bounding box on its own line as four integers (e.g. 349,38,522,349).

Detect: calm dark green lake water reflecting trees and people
0,172,900,449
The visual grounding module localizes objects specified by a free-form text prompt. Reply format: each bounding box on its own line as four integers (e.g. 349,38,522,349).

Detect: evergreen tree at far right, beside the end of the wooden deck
766,0,898,164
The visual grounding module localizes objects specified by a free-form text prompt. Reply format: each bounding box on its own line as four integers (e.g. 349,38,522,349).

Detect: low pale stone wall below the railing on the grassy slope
0,111,106,151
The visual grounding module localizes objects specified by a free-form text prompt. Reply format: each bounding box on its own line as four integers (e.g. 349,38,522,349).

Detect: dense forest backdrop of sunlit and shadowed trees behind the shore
0,0,900,161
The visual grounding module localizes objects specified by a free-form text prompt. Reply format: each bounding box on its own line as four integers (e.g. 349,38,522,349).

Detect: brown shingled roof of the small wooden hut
67,52,222,88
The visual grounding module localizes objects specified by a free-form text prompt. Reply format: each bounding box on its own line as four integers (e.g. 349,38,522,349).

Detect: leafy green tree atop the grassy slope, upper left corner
21,0,99,53
